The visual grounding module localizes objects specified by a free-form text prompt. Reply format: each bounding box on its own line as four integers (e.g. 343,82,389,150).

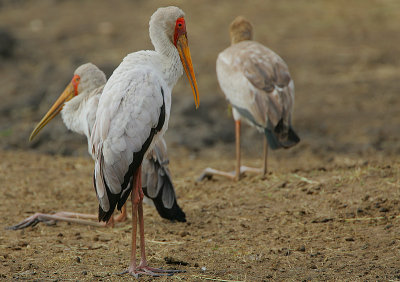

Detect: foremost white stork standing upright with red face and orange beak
91,7,199,276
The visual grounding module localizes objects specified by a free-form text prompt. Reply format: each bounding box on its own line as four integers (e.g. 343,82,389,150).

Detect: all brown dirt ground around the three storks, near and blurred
0,0,400,281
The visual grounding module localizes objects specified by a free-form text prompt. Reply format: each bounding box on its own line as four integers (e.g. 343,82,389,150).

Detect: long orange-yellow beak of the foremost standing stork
176,34,200,109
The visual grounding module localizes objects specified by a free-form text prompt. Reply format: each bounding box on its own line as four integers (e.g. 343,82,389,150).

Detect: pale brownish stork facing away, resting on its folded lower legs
199,16,300,180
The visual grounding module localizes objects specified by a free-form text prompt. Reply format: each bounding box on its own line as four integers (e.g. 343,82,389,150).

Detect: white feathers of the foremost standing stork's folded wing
94,69,169,198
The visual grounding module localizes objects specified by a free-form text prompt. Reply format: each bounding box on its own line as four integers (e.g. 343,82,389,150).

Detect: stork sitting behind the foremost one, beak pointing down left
9,63,186,230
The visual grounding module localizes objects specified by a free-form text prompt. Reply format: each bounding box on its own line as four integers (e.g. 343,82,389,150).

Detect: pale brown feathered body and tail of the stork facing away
217,41,300,149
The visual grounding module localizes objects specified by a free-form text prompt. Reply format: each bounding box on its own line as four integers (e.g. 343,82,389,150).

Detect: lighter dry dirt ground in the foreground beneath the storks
0,149,400,281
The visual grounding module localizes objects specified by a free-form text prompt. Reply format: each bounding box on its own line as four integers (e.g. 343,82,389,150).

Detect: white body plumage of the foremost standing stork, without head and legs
92,47,176,215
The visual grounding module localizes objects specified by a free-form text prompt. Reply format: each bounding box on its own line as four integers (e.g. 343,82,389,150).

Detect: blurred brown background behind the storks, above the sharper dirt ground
0,0,400,159
